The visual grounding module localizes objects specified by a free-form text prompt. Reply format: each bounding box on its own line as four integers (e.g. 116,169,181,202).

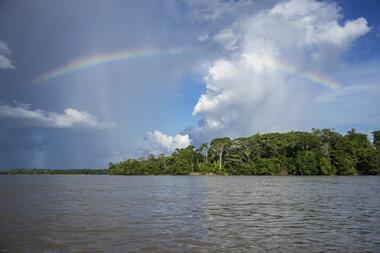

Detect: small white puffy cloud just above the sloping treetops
147,130,191,154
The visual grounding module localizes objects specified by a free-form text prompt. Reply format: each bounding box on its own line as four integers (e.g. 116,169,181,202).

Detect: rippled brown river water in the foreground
0,175,380,252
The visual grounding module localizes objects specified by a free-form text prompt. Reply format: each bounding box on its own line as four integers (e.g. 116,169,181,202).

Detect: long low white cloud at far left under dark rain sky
0,104,115,129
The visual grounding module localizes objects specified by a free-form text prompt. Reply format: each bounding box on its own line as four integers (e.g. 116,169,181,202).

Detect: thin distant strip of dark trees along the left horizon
0,169,108,175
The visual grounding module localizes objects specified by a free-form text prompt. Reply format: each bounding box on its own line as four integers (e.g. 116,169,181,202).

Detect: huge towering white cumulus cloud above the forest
193,0,370,139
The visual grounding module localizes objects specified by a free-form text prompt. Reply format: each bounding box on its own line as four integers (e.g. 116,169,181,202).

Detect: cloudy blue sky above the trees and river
0,0,380,169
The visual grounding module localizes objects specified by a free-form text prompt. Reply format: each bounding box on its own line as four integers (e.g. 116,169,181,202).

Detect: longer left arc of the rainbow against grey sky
34,49,182,82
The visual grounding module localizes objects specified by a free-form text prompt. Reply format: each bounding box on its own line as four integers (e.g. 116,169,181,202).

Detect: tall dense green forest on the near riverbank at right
109,129,380,175
